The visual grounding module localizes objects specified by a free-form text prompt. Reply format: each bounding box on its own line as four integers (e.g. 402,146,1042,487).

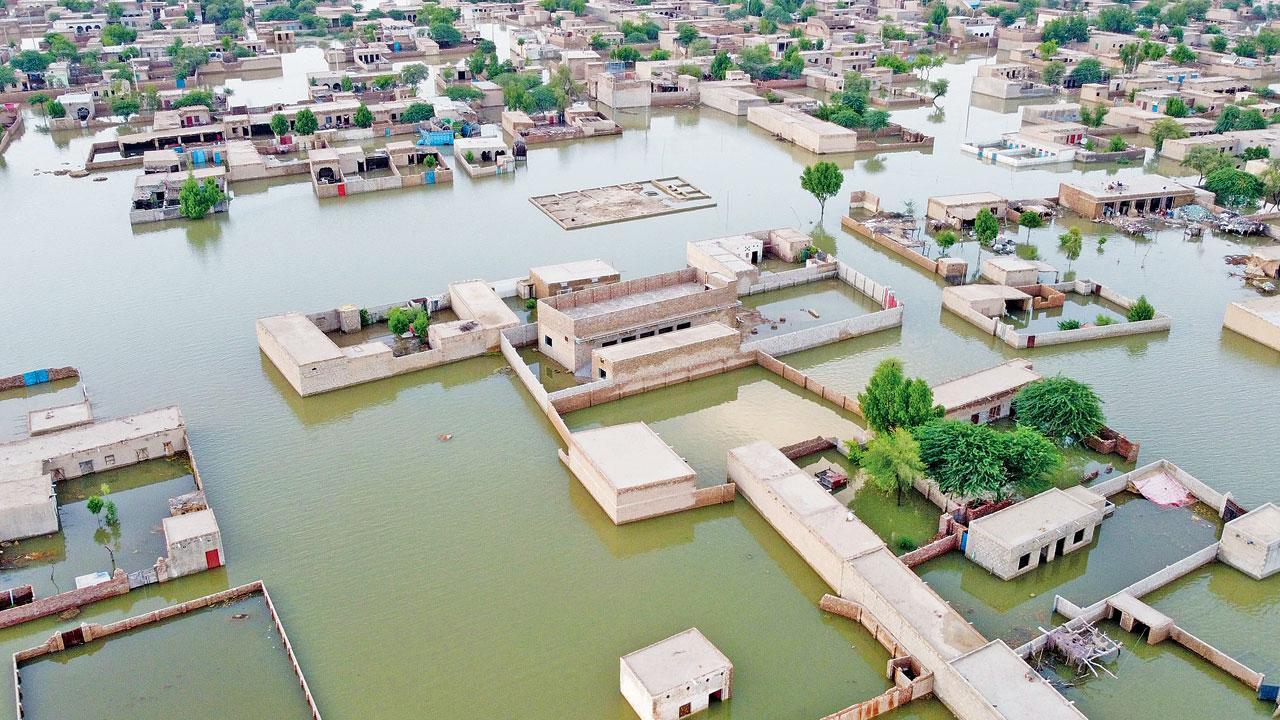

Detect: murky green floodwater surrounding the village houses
0,50,1280,720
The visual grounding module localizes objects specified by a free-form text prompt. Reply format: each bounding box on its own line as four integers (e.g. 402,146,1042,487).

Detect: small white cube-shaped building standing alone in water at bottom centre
618,628,733,720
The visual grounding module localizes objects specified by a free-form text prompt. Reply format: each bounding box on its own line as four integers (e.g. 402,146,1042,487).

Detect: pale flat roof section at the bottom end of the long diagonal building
951,641,1084,720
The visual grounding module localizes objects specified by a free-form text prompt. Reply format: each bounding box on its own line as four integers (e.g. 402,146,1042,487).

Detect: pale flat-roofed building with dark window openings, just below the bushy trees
964,486,1106,580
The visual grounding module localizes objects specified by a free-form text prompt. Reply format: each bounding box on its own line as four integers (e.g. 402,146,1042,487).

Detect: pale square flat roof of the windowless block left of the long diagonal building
573,423,696,491
